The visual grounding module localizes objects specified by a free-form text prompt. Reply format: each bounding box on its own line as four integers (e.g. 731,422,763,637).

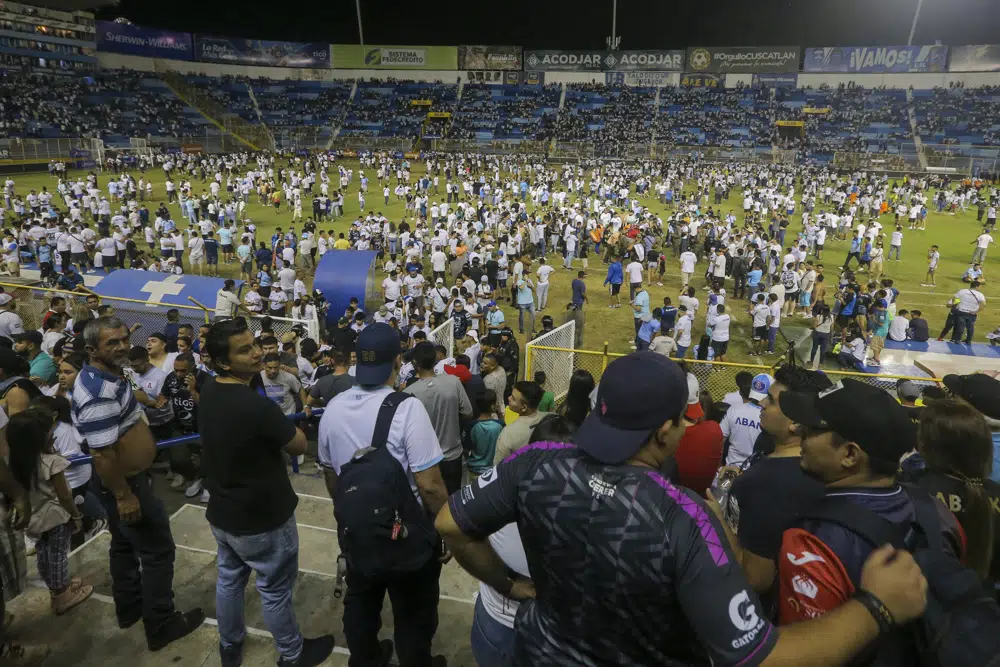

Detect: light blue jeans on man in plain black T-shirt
212,516,302,661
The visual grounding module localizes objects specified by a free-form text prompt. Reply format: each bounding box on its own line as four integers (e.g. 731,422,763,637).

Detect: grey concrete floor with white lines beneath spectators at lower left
8,475,478,667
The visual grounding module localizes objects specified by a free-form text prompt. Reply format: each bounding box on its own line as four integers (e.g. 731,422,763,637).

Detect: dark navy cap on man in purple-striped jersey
573,352,688,464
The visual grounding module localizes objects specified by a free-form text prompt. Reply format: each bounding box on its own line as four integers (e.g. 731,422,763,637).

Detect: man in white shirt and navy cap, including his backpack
319,323,448,667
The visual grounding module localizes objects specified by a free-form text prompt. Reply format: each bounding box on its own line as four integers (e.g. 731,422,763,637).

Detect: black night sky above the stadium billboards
99,0,1000,49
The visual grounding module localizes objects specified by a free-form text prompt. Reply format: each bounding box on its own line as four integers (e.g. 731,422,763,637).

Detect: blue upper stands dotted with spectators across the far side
0,65,1000,160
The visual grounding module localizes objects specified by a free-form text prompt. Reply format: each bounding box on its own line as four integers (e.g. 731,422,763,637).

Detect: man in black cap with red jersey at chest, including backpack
778,378,1000,667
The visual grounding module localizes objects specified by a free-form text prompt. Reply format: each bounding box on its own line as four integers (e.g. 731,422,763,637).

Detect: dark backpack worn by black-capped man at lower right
799,484,1000,667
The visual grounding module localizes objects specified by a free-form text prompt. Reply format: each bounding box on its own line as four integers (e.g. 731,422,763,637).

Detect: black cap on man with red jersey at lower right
778,378,917,462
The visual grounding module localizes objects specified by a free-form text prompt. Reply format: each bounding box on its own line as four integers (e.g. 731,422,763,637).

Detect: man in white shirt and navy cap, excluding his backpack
318,324,448,665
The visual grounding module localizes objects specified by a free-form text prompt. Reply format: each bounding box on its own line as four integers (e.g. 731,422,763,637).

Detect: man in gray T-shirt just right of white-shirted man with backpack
405,342,472,494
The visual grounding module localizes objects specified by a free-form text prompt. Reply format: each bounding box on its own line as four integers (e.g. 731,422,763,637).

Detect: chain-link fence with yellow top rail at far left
0,282,209,343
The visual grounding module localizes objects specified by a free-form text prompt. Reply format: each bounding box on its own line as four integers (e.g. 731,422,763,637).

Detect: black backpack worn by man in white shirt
333,392,439,578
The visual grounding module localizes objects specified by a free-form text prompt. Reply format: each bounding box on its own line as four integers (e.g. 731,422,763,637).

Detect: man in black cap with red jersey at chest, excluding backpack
778,378,962,664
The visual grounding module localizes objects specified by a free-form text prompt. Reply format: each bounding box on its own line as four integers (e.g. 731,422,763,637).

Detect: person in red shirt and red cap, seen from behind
672,373,724,498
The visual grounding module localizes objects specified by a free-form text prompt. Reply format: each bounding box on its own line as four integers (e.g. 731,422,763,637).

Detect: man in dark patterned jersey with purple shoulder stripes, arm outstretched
437,352,926,667
